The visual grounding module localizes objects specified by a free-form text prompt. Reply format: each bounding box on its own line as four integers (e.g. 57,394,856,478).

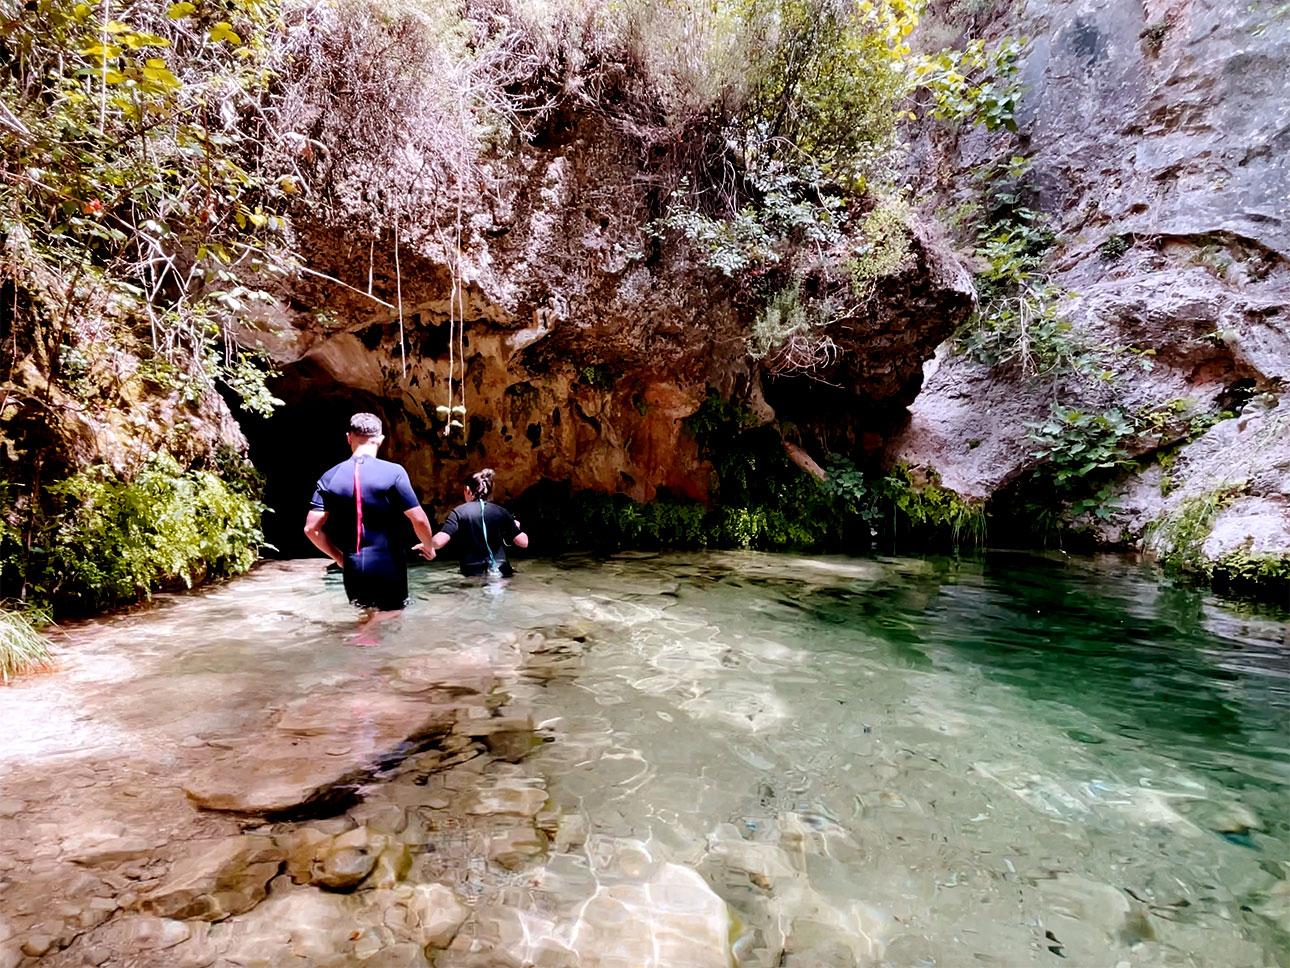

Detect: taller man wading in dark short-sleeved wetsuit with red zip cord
304,413,435,612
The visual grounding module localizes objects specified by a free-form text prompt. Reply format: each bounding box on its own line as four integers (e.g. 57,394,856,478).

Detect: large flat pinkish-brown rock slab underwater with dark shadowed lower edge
183,691,466,814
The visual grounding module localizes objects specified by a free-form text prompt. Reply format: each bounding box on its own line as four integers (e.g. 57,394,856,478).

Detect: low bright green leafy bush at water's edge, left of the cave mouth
3,456,264,613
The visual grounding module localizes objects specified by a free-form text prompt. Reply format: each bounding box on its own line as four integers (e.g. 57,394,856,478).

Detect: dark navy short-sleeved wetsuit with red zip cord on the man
310,457,421,609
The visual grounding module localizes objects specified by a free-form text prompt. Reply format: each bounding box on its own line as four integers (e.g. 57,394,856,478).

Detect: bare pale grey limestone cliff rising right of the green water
888,0,1290,573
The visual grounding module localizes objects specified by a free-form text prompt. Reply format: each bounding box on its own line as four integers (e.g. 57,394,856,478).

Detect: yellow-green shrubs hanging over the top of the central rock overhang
650,0,1022,370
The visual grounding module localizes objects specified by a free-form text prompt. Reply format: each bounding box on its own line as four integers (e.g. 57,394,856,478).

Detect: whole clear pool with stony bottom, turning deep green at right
0,552,1290,968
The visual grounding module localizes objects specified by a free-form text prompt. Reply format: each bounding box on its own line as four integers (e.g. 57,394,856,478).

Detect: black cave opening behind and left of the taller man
237,361,397,558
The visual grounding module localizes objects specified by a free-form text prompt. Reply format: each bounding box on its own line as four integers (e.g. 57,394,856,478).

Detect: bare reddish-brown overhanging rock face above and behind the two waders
248,116,973,531
